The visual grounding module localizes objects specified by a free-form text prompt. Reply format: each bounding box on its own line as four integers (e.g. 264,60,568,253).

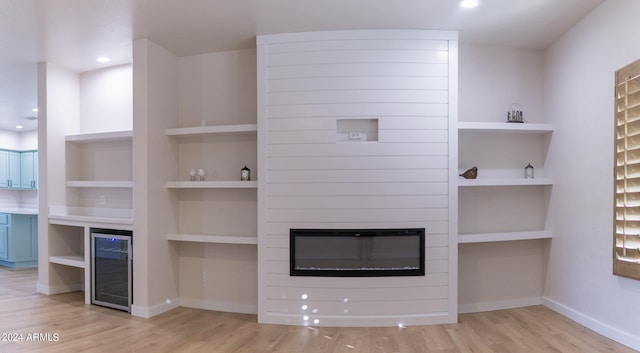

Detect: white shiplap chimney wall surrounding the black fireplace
257,30,457,326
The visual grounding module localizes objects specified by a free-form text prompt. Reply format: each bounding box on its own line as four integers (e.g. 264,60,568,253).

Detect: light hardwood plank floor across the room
0,267,635,353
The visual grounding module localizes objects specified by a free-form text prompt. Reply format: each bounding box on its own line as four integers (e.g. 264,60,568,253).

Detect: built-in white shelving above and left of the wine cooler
48,130,133,304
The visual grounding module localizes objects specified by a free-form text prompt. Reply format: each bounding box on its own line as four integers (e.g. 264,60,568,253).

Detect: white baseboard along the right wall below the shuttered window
542,297,640,351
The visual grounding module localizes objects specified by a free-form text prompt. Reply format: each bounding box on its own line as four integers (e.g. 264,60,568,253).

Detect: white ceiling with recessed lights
0,0,605,130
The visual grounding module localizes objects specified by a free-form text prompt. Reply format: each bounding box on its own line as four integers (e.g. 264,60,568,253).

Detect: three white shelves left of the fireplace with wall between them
166,124,258,245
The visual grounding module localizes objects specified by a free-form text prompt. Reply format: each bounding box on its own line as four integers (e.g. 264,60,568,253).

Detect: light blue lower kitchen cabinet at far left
0,213,38,267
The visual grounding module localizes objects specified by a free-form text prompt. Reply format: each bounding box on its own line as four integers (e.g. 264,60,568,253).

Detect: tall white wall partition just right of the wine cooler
131,39,179,317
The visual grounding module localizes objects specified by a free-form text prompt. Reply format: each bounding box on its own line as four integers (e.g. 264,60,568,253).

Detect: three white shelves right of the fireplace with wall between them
458,122,553,243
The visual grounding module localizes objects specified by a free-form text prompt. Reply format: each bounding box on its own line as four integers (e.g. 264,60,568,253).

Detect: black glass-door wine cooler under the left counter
91,229,133,312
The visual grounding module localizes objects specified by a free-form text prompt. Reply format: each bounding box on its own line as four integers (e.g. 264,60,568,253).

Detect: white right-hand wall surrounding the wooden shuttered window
544,0,640,349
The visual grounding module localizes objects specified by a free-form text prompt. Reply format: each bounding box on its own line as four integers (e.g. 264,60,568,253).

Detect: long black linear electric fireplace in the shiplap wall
289,228,425,277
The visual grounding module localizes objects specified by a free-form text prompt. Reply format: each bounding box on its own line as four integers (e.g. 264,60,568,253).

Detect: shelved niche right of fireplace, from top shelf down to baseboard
458,122,553,313
